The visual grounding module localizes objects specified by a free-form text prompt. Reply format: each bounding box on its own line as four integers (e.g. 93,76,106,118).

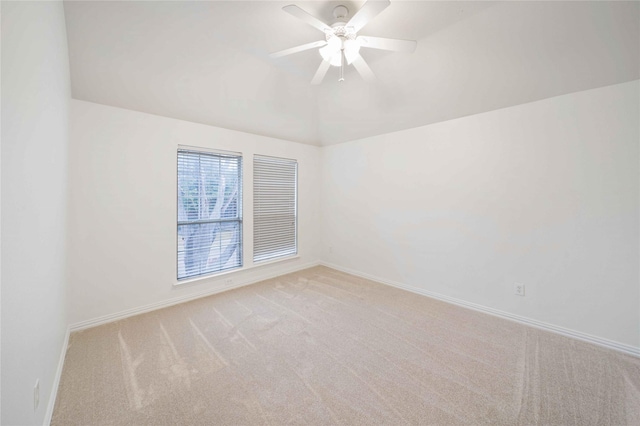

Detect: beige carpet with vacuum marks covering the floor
52,267,640,425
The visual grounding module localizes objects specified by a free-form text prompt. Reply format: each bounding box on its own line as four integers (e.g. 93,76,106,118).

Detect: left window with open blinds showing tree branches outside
178,149,242,280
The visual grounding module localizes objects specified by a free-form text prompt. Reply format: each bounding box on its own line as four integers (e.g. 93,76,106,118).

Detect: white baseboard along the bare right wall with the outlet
320,261,640,357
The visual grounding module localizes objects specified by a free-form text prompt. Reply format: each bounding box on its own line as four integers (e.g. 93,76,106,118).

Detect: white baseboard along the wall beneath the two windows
69,261,320,333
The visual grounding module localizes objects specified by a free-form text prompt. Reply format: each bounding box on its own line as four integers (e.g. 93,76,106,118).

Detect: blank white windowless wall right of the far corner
322,81,640,348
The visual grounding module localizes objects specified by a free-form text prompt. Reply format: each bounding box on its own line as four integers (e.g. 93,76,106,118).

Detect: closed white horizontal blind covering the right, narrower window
253,155,298,262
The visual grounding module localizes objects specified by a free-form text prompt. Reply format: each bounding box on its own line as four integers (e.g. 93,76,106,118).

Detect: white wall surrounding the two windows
69,100,320,324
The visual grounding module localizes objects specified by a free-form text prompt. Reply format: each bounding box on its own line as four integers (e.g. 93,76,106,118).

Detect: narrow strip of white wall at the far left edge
0,2,71,425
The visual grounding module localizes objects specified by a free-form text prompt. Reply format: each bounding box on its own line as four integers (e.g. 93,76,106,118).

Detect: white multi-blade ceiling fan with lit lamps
269,0,417,84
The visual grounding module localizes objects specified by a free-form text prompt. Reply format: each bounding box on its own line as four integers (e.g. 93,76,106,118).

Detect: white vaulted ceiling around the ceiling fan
65,0,640,145
